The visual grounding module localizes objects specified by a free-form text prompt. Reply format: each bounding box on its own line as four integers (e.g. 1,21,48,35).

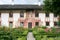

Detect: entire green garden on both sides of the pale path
0,26,60,40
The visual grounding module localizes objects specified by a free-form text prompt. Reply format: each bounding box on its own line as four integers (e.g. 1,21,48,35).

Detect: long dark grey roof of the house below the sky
0,5,42,10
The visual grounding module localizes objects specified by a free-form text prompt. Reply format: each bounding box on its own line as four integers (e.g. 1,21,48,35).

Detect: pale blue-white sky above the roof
0,0,43,5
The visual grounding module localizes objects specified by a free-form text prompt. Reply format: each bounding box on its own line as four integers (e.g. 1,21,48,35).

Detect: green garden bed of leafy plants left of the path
0,27,28,40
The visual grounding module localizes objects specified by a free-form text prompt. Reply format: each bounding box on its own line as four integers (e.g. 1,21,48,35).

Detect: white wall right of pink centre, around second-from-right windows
39,13,54,27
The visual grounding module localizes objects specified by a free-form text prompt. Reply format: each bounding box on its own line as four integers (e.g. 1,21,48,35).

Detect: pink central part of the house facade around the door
19,11,41,28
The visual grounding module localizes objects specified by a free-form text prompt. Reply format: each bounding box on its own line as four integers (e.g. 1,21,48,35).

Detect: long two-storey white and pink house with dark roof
0,5,58,28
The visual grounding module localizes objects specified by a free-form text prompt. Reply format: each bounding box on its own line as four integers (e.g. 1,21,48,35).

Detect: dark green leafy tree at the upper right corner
44,0,60,25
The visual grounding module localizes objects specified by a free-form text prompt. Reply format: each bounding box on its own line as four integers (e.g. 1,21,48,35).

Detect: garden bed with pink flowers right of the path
32,26,60,40
